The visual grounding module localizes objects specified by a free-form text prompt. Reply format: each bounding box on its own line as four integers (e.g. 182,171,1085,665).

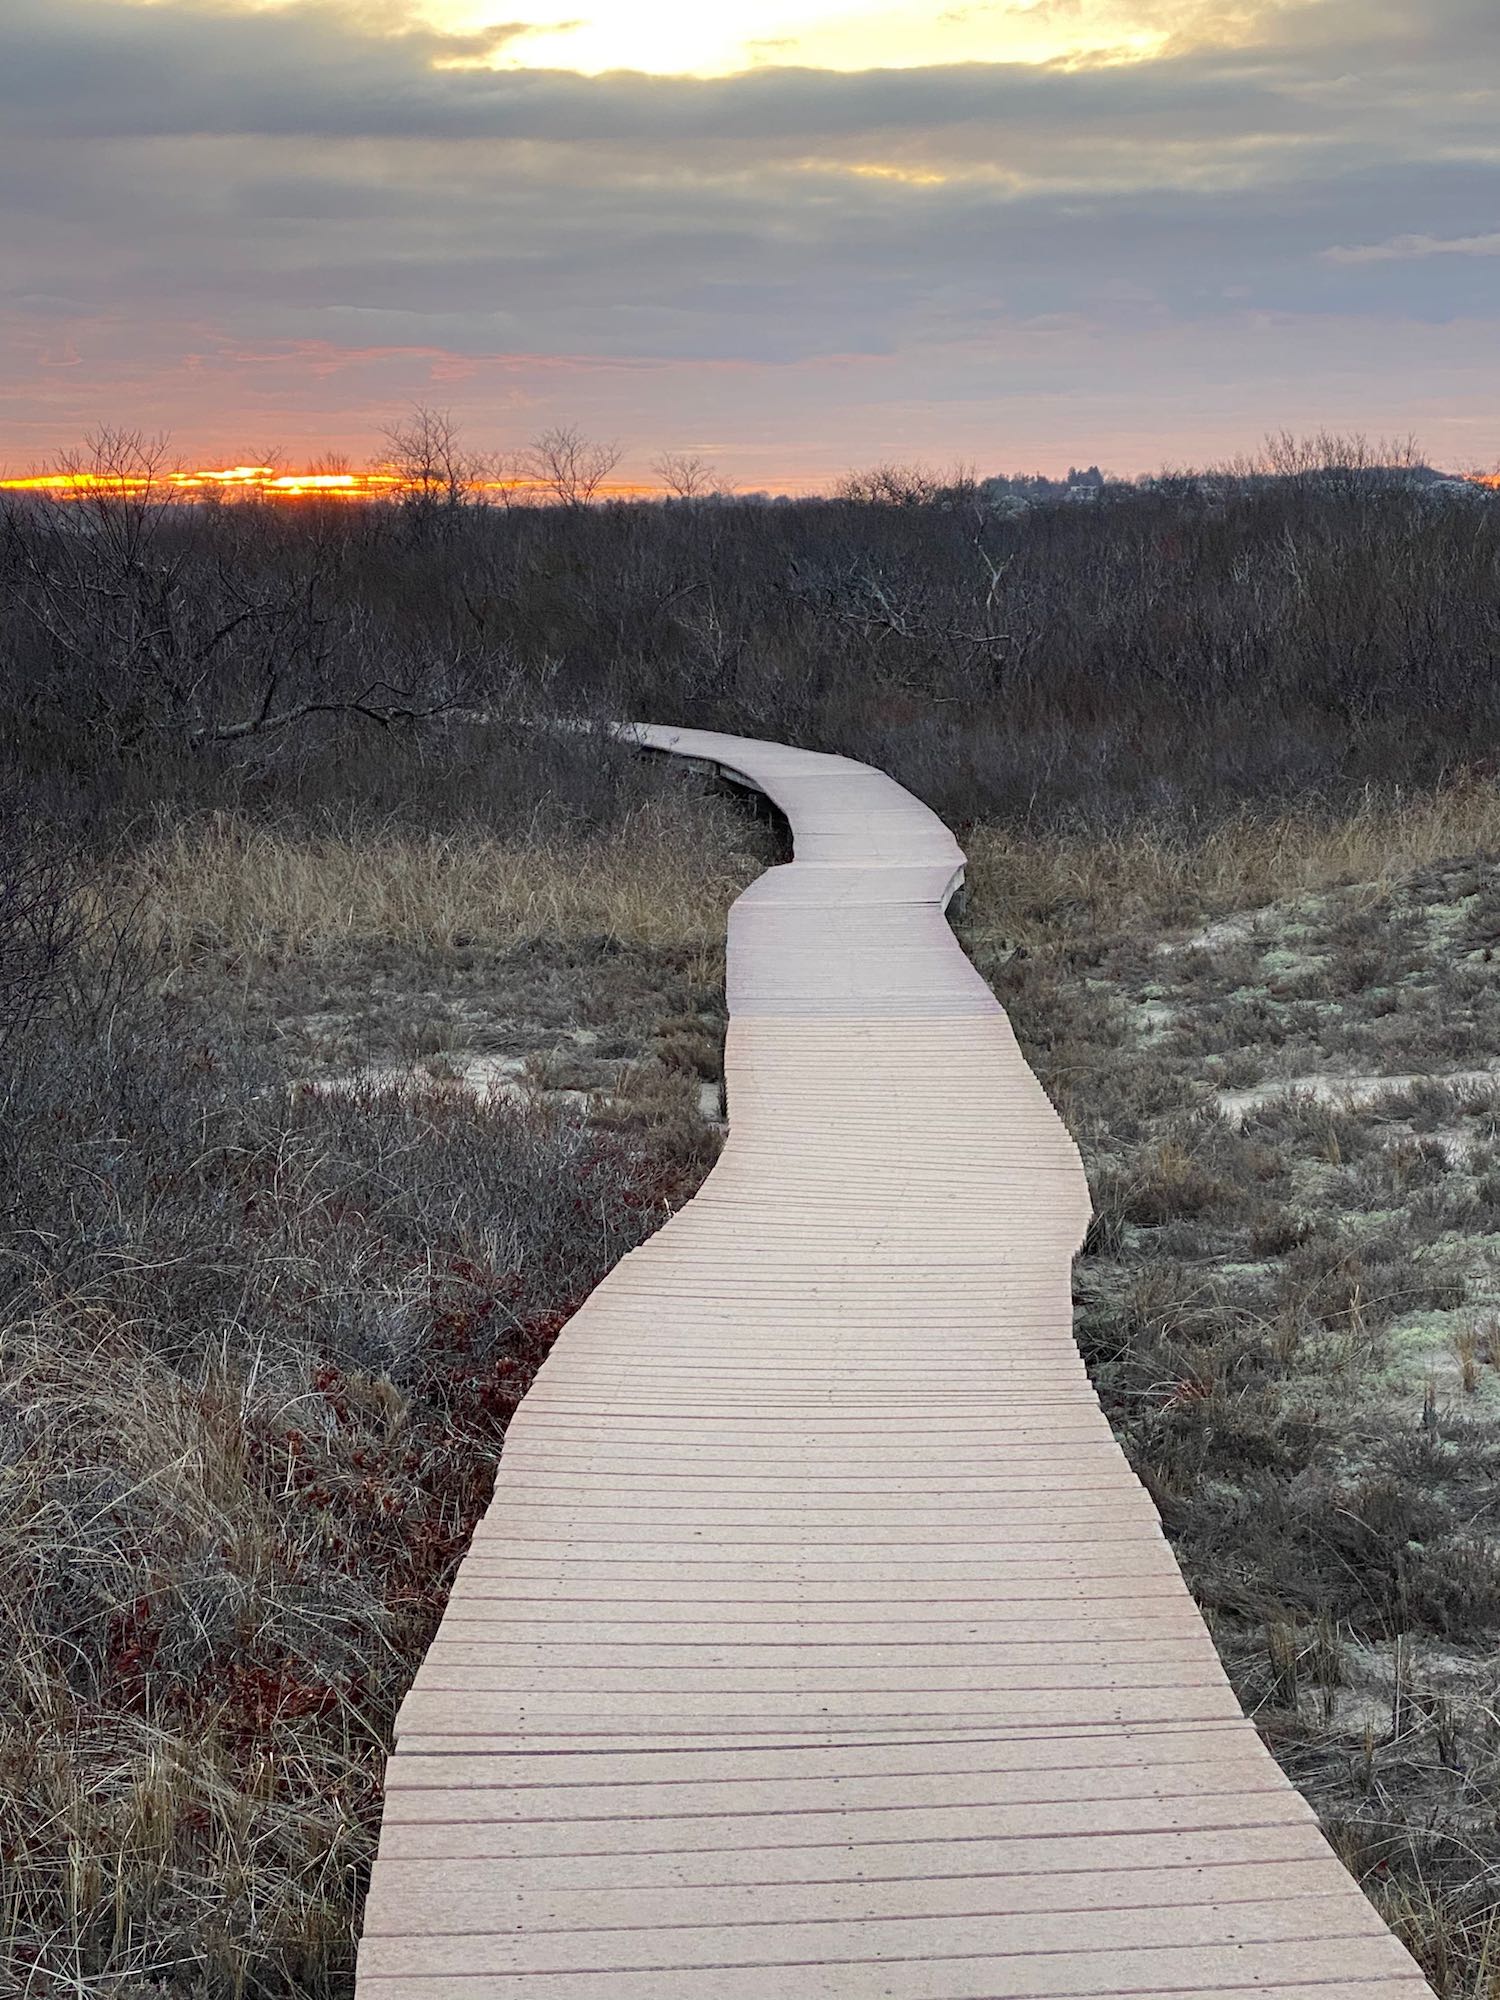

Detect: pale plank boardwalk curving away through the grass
358,728,1428,2000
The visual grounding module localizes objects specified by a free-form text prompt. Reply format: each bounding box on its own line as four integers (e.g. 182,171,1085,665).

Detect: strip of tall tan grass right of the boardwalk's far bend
964,774,1500,946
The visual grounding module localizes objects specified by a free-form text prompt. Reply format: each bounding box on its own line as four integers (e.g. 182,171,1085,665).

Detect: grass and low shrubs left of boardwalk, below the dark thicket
0,772,764,2000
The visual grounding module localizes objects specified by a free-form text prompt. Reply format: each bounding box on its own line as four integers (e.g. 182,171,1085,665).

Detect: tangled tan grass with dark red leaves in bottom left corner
0,1302,382,1994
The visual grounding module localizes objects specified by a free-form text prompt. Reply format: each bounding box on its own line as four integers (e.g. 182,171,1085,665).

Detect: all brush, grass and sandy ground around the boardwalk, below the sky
0,446,1500,2000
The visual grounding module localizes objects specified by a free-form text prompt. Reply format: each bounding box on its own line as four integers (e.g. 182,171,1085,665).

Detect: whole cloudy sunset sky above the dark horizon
0,0,1500,490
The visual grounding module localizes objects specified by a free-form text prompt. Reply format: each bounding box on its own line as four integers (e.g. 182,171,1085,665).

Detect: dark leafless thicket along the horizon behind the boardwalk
0,434,1500,840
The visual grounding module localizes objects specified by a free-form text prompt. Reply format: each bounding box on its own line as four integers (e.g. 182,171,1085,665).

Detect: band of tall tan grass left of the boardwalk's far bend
102,796,764,964
